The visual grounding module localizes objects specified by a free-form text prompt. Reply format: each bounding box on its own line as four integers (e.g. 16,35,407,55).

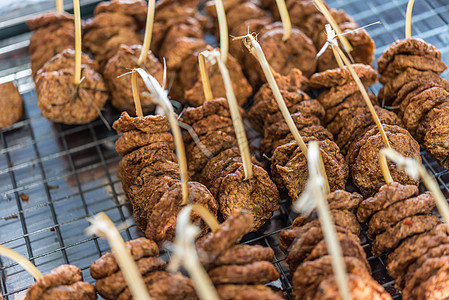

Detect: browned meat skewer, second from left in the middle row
182,98,279,230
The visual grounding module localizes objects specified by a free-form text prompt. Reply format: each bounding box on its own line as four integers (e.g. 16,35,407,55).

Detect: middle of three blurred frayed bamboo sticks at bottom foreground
167,205,219,300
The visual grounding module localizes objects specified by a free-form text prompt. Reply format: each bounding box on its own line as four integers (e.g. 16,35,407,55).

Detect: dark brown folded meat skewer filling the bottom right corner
357,182,449,300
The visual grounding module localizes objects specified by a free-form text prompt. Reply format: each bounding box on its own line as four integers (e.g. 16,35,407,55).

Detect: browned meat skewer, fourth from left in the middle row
309,64,420,196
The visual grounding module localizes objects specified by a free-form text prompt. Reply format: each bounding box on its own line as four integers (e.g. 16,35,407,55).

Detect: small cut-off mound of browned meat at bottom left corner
25,265,97,300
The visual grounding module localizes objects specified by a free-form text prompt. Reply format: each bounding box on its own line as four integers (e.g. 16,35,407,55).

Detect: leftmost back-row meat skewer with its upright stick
27,1,108,124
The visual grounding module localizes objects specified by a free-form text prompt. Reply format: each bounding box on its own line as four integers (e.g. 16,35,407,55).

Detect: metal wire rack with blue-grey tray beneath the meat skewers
0,0,449,299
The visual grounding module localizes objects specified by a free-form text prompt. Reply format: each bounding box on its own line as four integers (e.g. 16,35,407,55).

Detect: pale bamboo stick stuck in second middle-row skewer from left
202,50,253,180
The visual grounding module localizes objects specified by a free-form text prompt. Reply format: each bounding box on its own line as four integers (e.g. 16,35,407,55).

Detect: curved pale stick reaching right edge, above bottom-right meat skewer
379,148,449,226
